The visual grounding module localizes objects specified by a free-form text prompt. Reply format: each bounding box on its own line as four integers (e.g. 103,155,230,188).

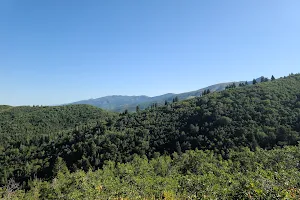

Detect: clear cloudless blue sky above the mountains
0,0,300,105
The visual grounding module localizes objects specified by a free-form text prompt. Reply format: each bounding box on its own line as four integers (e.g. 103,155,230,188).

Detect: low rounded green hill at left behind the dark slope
0,105,113,138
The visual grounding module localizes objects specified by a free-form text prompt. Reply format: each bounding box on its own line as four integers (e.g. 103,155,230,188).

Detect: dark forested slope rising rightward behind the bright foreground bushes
0,75,300,189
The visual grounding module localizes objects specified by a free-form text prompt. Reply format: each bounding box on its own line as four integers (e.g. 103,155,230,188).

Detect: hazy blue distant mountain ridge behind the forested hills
70,77,261,112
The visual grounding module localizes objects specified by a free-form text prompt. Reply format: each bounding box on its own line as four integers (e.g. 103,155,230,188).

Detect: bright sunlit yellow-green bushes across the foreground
0,146,300,200
